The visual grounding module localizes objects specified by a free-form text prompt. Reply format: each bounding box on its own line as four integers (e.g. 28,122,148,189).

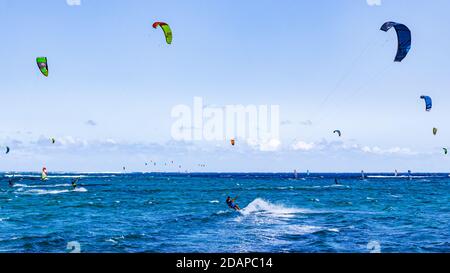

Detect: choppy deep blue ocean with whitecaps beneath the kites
0,173,450,253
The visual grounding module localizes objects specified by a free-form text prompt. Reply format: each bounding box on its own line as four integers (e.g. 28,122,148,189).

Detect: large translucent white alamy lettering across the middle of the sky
171,97,280,143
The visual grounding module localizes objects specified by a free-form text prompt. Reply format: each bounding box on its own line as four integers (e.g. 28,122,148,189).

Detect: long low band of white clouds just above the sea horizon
5,132,420,159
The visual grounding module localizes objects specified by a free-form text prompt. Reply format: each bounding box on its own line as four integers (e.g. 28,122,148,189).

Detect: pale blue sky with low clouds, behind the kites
0,0,450,172
